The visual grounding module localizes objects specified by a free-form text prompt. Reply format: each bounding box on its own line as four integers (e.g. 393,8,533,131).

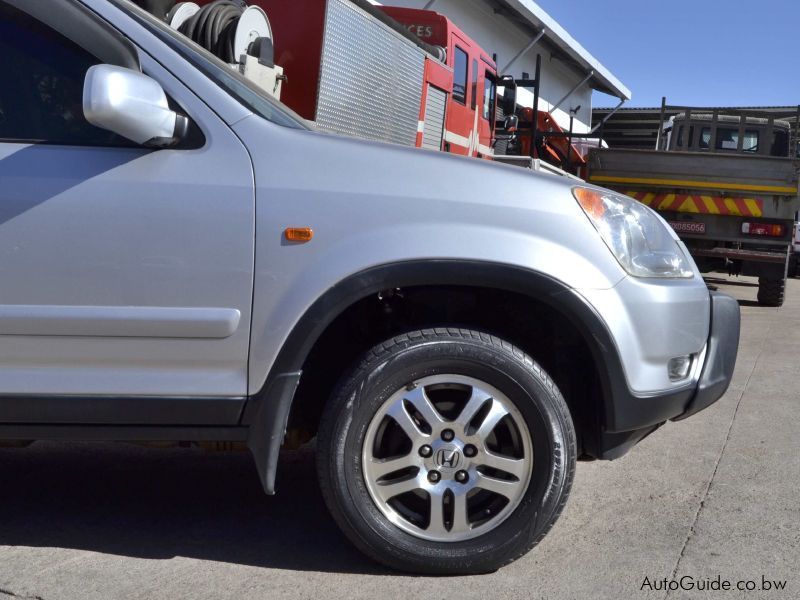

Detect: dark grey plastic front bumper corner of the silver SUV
596,292,740,459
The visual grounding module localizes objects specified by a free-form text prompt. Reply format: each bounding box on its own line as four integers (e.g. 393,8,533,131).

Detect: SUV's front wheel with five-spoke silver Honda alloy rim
317,328,576,574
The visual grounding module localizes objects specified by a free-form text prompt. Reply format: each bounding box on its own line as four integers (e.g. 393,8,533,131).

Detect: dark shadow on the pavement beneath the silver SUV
0,442,386,574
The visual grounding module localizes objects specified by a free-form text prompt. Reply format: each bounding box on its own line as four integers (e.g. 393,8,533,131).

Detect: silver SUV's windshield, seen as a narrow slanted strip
104,0,310,129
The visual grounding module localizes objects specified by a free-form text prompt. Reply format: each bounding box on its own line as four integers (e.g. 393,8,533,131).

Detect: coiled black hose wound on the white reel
178,0,247,63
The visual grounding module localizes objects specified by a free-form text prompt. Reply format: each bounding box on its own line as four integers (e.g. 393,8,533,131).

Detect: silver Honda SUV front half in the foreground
0,0,739,573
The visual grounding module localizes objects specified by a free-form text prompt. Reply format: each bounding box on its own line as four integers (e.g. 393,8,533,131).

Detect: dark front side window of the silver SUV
0,2,133,146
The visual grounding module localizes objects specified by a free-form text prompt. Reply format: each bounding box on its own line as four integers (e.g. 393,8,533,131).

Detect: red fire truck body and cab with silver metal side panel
250,0,497,157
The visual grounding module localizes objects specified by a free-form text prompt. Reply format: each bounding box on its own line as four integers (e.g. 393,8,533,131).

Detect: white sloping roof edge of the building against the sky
497,0,631,100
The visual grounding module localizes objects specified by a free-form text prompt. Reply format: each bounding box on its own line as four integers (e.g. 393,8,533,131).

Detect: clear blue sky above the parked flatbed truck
534,0,800,107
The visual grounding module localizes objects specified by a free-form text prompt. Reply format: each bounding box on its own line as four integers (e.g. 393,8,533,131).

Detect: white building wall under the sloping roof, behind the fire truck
382,0,592,133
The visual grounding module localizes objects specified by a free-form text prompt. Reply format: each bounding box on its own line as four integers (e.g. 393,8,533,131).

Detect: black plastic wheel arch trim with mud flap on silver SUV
248,259,694,494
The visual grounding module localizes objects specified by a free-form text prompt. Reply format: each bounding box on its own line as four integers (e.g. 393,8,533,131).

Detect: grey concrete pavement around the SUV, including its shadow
0,278,800,600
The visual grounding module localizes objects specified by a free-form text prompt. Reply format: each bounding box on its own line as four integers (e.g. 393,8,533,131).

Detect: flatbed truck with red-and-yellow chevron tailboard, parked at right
587,105,800,306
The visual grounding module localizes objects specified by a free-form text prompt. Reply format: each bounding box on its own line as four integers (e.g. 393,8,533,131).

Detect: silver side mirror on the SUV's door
83,65,189,148
